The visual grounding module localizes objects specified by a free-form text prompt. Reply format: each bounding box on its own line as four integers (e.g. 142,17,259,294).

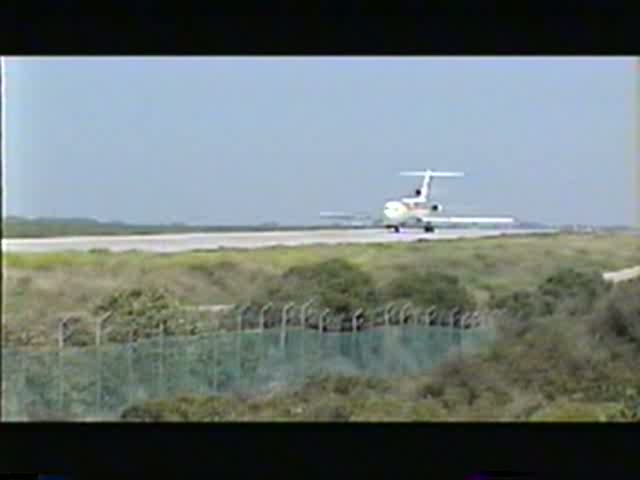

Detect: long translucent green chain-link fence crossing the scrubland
2,308,504,421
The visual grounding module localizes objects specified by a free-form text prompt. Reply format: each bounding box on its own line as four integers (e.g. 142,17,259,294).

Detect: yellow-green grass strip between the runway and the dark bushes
3,234,640,345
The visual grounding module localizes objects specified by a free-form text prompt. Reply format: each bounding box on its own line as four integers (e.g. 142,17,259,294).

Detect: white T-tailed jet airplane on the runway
322,170,515,233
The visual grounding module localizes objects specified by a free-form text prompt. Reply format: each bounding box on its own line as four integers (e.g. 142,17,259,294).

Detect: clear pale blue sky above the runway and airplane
5,57,635,224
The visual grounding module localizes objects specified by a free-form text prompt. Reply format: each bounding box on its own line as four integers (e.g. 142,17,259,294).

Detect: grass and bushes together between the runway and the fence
3,235,640,347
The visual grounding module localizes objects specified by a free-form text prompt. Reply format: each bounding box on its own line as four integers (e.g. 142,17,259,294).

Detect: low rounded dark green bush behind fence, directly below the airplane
383,270,476,310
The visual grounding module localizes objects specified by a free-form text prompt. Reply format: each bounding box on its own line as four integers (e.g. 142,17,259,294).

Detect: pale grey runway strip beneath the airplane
2,229,551,253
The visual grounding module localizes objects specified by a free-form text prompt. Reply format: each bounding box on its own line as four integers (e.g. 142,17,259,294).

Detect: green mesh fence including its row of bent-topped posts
2,299,506,419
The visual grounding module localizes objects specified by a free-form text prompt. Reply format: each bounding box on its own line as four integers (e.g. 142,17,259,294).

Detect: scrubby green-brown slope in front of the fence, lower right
121,280,640,421
